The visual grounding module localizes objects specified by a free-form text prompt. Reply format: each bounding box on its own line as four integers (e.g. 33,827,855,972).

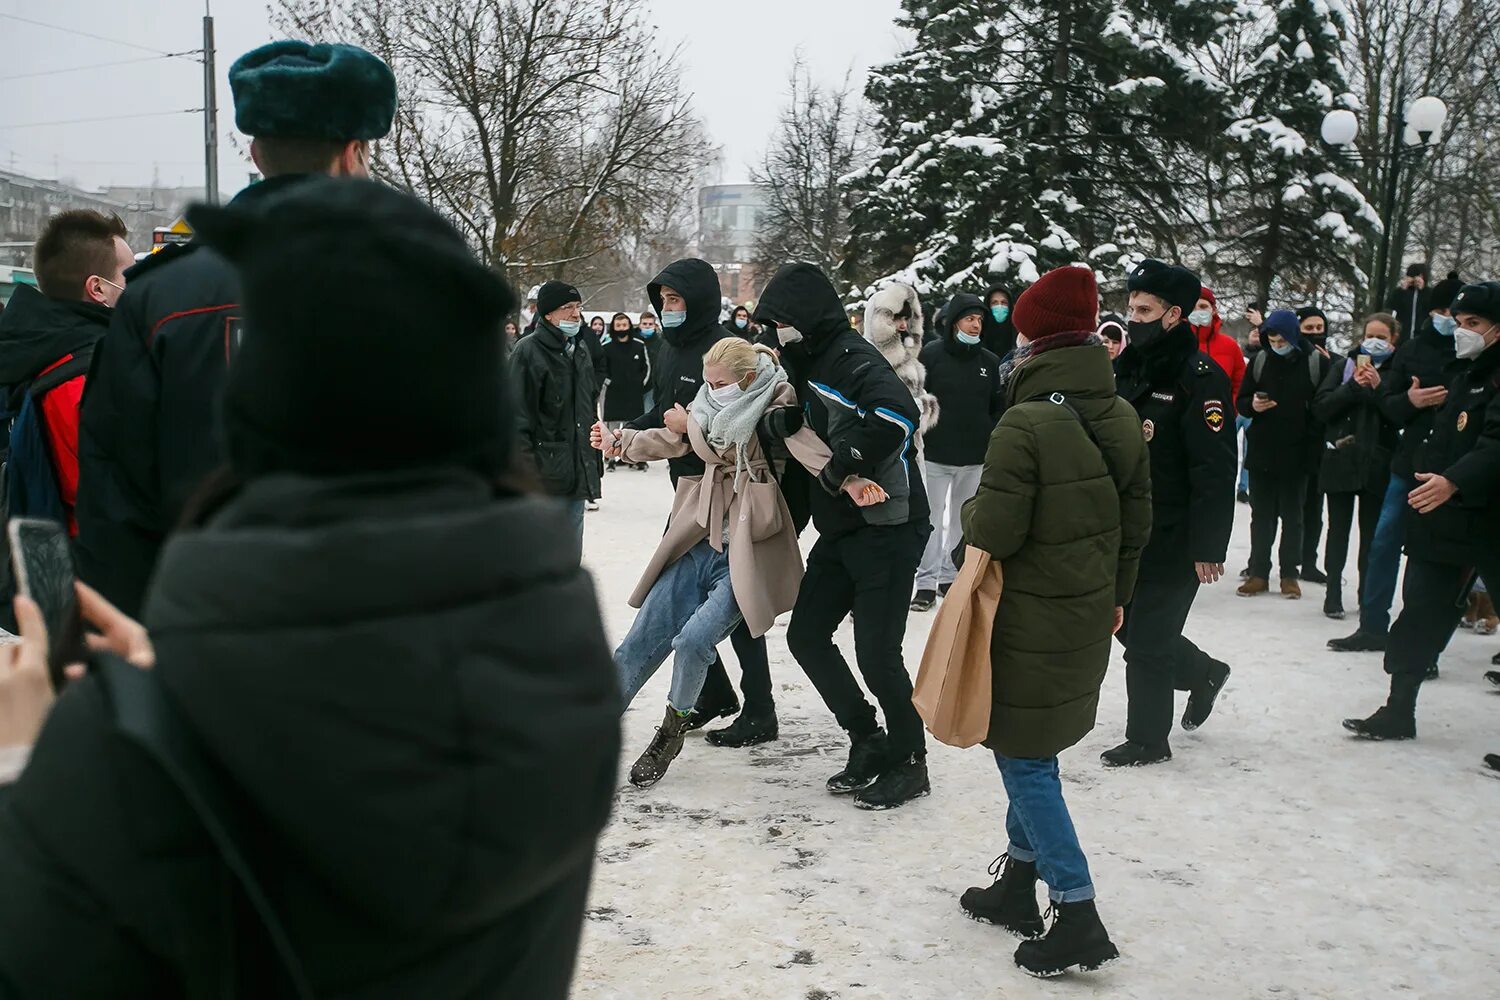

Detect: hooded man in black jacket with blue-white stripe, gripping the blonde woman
755,264,932,810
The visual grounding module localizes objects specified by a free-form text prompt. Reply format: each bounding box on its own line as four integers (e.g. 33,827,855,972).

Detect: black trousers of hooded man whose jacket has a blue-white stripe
786,519,932,757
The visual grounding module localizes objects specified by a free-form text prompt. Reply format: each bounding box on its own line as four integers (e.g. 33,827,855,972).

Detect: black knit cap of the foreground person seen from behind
188,177,515,478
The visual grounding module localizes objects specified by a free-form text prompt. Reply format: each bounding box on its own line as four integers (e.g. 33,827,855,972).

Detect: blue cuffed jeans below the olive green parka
995,753,1094,903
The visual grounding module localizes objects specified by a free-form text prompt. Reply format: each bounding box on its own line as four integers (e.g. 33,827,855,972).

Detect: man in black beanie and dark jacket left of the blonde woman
510,282,602,547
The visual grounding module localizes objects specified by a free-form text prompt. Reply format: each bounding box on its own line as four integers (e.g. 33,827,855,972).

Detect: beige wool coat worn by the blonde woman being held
620,384,831,636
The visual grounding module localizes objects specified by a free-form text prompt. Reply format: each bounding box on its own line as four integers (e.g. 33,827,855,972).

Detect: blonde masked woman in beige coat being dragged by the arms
594,339,885,787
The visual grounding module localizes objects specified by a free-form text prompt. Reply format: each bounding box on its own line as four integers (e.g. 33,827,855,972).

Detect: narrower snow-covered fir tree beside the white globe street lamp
1208,0,1380,300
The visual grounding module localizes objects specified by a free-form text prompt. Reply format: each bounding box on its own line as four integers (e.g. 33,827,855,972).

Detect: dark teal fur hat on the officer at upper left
230,40,396,142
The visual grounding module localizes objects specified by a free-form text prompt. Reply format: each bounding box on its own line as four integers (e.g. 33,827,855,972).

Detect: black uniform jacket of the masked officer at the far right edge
1407,343,1500,565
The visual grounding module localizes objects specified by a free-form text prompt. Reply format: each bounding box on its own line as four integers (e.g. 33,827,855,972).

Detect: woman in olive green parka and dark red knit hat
963,267,1151,975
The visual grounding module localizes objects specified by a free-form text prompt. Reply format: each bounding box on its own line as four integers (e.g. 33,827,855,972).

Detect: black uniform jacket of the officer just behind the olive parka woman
1116,322,1239,579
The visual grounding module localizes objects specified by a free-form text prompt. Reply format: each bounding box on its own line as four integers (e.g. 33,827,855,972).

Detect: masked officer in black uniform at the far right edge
1344,282,1500,749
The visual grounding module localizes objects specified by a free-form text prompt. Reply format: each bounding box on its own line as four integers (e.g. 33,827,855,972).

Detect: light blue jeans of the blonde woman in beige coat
615,540,740,712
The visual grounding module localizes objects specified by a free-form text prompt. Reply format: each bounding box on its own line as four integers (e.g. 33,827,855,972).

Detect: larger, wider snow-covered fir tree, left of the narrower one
846,0,1238,292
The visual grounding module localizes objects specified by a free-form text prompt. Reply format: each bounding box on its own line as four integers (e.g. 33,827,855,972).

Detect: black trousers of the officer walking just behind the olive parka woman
1115,563,1218,744
